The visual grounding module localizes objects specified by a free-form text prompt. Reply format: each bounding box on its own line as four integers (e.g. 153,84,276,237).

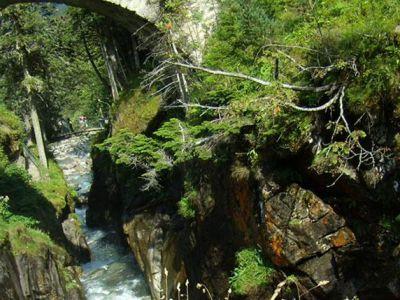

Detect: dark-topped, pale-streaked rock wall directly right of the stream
87,150,186,300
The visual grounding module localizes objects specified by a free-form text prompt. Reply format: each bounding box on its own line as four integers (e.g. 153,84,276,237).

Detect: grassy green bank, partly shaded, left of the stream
0,120,69,241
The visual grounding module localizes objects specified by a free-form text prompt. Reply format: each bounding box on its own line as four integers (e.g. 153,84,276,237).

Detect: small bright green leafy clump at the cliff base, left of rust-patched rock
229,248,275,295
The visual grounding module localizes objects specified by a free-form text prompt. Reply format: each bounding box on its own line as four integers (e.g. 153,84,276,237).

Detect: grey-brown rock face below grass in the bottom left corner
0,246,84,300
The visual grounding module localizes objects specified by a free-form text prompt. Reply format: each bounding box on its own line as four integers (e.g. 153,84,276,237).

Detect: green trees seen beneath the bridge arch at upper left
0,4,110,136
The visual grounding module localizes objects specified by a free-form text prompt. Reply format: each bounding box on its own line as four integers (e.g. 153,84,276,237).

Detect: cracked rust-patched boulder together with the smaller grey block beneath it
264,184,356,292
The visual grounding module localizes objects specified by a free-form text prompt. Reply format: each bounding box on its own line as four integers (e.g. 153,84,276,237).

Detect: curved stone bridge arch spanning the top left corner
0,0,161,33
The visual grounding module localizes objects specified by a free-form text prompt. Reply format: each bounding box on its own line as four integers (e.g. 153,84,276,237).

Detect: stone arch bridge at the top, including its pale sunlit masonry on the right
0,0,218,63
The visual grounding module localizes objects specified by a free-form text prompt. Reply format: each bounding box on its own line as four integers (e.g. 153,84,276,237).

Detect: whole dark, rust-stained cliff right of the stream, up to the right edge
89,144,399,299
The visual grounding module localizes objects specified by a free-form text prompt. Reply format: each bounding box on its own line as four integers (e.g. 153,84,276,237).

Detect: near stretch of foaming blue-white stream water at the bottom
76,208,150,300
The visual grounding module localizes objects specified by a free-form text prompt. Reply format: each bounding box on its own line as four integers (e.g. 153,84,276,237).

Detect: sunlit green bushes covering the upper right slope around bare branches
184,0,400,164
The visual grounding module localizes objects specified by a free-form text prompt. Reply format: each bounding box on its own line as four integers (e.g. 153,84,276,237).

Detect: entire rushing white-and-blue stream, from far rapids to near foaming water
50,136,150,300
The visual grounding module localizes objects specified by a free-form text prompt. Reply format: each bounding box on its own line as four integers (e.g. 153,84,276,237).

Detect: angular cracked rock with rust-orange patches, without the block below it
265,185,355,266
